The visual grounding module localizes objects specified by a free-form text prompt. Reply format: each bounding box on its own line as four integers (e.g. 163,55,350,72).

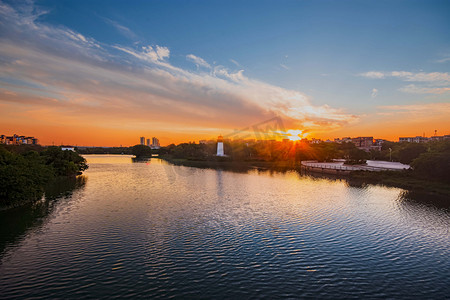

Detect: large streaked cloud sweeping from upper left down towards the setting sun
0,3,358,139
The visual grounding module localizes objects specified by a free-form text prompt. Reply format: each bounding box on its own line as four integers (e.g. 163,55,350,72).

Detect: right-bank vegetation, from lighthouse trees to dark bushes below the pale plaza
159,141,450,197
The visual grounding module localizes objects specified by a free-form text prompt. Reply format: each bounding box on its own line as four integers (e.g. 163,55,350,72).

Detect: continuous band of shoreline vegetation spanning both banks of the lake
0,140,450,209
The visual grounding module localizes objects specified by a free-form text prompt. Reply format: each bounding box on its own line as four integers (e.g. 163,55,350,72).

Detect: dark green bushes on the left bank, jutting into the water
0,145,88,209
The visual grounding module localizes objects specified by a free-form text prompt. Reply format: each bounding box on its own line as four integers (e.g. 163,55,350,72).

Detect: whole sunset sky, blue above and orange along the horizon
0,0,450,146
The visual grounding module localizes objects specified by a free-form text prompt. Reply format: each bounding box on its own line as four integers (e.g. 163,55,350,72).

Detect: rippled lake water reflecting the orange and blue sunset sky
0,155,450,299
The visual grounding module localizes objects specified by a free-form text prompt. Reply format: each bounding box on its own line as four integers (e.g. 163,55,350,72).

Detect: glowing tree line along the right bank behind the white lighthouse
160,141,450,182
